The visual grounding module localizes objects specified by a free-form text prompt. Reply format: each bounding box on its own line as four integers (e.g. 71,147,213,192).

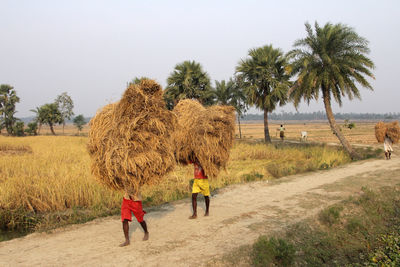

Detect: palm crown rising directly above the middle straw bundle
164,61,214,109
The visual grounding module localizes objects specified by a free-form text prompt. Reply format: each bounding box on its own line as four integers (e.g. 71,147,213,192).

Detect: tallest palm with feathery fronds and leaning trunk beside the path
288,23,374,158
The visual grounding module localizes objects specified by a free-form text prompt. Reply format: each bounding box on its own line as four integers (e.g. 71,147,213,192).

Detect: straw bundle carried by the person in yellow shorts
173,99,235,177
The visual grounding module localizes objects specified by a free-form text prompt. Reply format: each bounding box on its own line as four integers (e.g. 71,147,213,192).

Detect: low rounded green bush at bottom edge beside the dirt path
252,236,296,266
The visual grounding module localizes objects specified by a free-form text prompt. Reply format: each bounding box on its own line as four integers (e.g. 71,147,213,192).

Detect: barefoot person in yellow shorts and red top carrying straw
189,159,210,219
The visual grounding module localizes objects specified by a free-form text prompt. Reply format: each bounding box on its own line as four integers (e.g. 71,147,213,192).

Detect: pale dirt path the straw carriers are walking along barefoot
0,155,400,266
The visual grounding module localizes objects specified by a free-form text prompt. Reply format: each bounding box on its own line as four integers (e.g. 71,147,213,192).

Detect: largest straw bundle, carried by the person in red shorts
87,79,177,194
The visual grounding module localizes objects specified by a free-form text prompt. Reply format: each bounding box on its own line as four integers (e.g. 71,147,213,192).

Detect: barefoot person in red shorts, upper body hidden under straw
119,192,149,247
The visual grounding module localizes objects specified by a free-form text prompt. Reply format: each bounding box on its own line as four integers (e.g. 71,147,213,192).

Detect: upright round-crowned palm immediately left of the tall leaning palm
236,45,291,143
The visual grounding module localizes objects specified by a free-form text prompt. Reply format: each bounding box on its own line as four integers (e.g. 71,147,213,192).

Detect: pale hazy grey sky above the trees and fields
0,0,400,117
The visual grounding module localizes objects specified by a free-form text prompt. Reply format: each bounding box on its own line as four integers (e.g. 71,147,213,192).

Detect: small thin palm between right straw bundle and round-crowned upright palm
214,77,247,139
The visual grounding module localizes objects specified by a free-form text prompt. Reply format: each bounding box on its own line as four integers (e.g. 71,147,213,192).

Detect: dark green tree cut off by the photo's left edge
0,84,19,135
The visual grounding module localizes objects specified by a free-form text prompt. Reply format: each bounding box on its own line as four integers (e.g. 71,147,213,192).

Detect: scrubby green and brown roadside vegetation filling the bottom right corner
250,185,400,266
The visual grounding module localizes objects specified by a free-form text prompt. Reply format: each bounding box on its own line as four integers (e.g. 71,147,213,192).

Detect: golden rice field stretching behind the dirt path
0,123,382,240
